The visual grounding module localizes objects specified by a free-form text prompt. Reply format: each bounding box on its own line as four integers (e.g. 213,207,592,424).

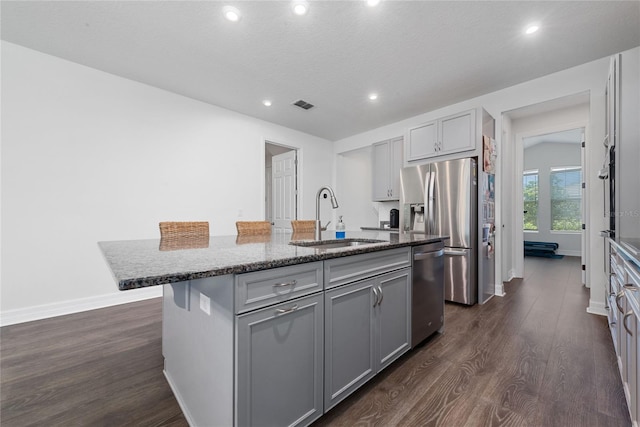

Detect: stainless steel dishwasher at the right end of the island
411,241,444,348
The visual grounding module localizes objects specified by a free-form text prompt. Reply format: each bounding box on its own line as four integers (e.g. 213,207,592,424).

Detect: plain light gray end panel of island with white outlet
162,276,234,426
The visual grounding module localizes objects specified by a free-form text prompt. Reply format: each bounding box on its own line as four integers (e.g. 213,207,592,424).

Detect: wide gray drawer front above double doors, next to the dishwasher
324,247,411,289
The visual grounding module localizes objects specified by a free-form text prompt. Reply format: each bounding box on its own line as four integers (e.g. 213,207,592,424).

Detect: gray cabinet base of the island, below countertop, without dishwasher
162,247,420,427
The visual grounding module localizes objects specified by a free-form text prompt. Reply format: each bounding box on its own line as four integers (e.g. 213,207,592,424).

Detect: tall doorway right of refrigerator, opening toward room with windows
501,92,589,284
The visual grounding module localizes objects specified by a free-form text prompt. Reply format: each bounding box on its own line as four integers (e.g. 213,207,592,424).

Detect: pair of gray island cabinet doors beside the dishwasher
324,268,411,411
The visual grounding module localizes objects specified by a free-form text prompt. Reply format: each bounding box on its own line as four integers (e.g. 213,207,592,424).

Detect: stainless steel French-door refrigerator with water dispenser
400,158,479,305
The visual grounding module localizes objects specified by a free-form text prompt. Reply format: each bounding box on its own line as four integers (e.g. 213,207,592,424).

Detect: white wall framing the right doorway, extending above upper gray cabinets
334,48,640,314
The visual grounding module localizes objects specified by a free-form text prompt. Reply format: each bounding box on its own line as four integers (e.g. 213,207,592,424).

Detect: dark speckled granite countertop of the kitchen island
98,231,443,290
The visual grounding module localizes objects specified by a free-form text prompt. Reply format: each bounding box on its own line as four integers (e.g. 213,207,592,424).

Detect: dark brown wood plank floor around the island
0,257,630,427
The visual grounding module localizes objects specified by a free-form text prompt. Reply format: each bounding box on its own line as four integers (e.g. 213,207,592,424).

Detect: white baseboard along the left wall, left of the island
0,286,162,326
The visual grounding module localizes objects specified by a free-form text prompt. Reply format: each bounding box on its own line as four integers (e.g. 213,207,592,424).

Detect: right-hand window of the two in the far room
550,167,582,231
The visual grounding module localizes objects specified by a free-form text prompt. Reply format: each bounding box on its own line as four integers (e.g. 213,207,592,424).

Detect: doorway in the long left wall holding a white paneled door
264,141,298,232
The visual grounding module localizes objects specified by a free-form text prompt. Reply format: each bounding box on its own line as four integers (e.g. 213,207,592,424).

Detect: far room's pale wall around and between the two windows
523,142,581,256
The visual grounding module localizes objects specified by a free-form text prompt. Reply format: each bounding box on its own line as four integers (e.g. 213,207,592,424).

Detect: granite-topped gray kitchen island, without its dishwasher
99,231,442,426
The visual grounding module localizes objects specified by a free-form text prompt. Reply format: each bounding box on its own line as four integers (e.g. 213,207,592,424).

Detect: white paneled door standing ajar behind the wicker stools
271,150,297,231
